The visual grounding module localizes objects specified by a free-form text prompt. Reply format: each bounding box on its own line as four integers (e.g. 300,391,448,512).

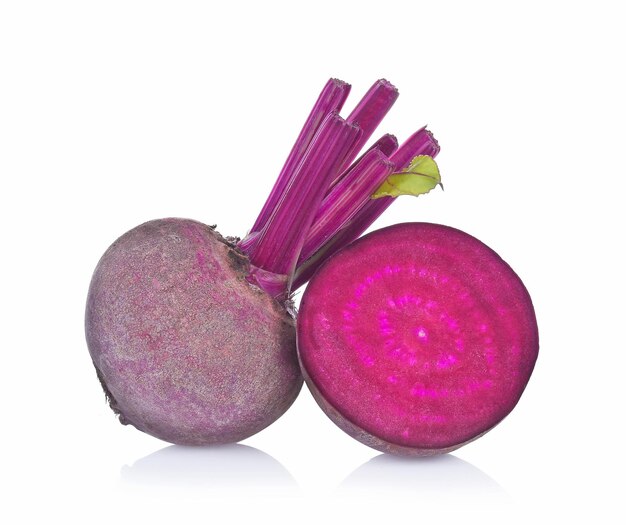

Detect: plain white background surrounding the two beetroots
0,0,626,523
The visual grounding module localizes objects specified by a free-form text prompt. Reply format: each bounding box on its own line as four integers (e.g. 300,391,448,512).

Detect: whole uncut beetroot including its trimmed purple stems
86,79,439,445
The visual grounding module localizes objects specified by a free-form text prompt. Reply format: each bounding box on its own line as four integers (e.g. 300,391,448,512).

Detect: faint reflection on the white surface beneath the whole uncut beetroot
121,445,297,491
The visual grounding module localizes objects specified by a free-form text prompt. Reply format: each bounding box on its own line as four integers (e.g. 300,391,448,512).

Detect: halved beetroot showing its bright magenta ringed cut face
297,223,539,456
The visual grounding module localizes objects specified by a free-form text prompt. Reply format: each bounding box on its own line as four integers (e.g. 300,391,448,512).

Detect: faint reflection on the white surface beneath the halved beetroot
339,454,506,496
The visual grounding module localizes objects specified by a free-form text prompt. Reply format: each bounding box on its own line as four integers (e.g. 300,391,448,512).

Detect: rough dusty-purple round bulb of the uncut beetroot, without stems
86,219,302,445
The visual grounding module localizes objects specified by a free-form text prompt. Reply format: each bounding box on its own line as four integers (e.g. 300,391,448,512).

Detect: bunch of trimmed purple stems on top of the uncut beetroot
239,79,439,298
